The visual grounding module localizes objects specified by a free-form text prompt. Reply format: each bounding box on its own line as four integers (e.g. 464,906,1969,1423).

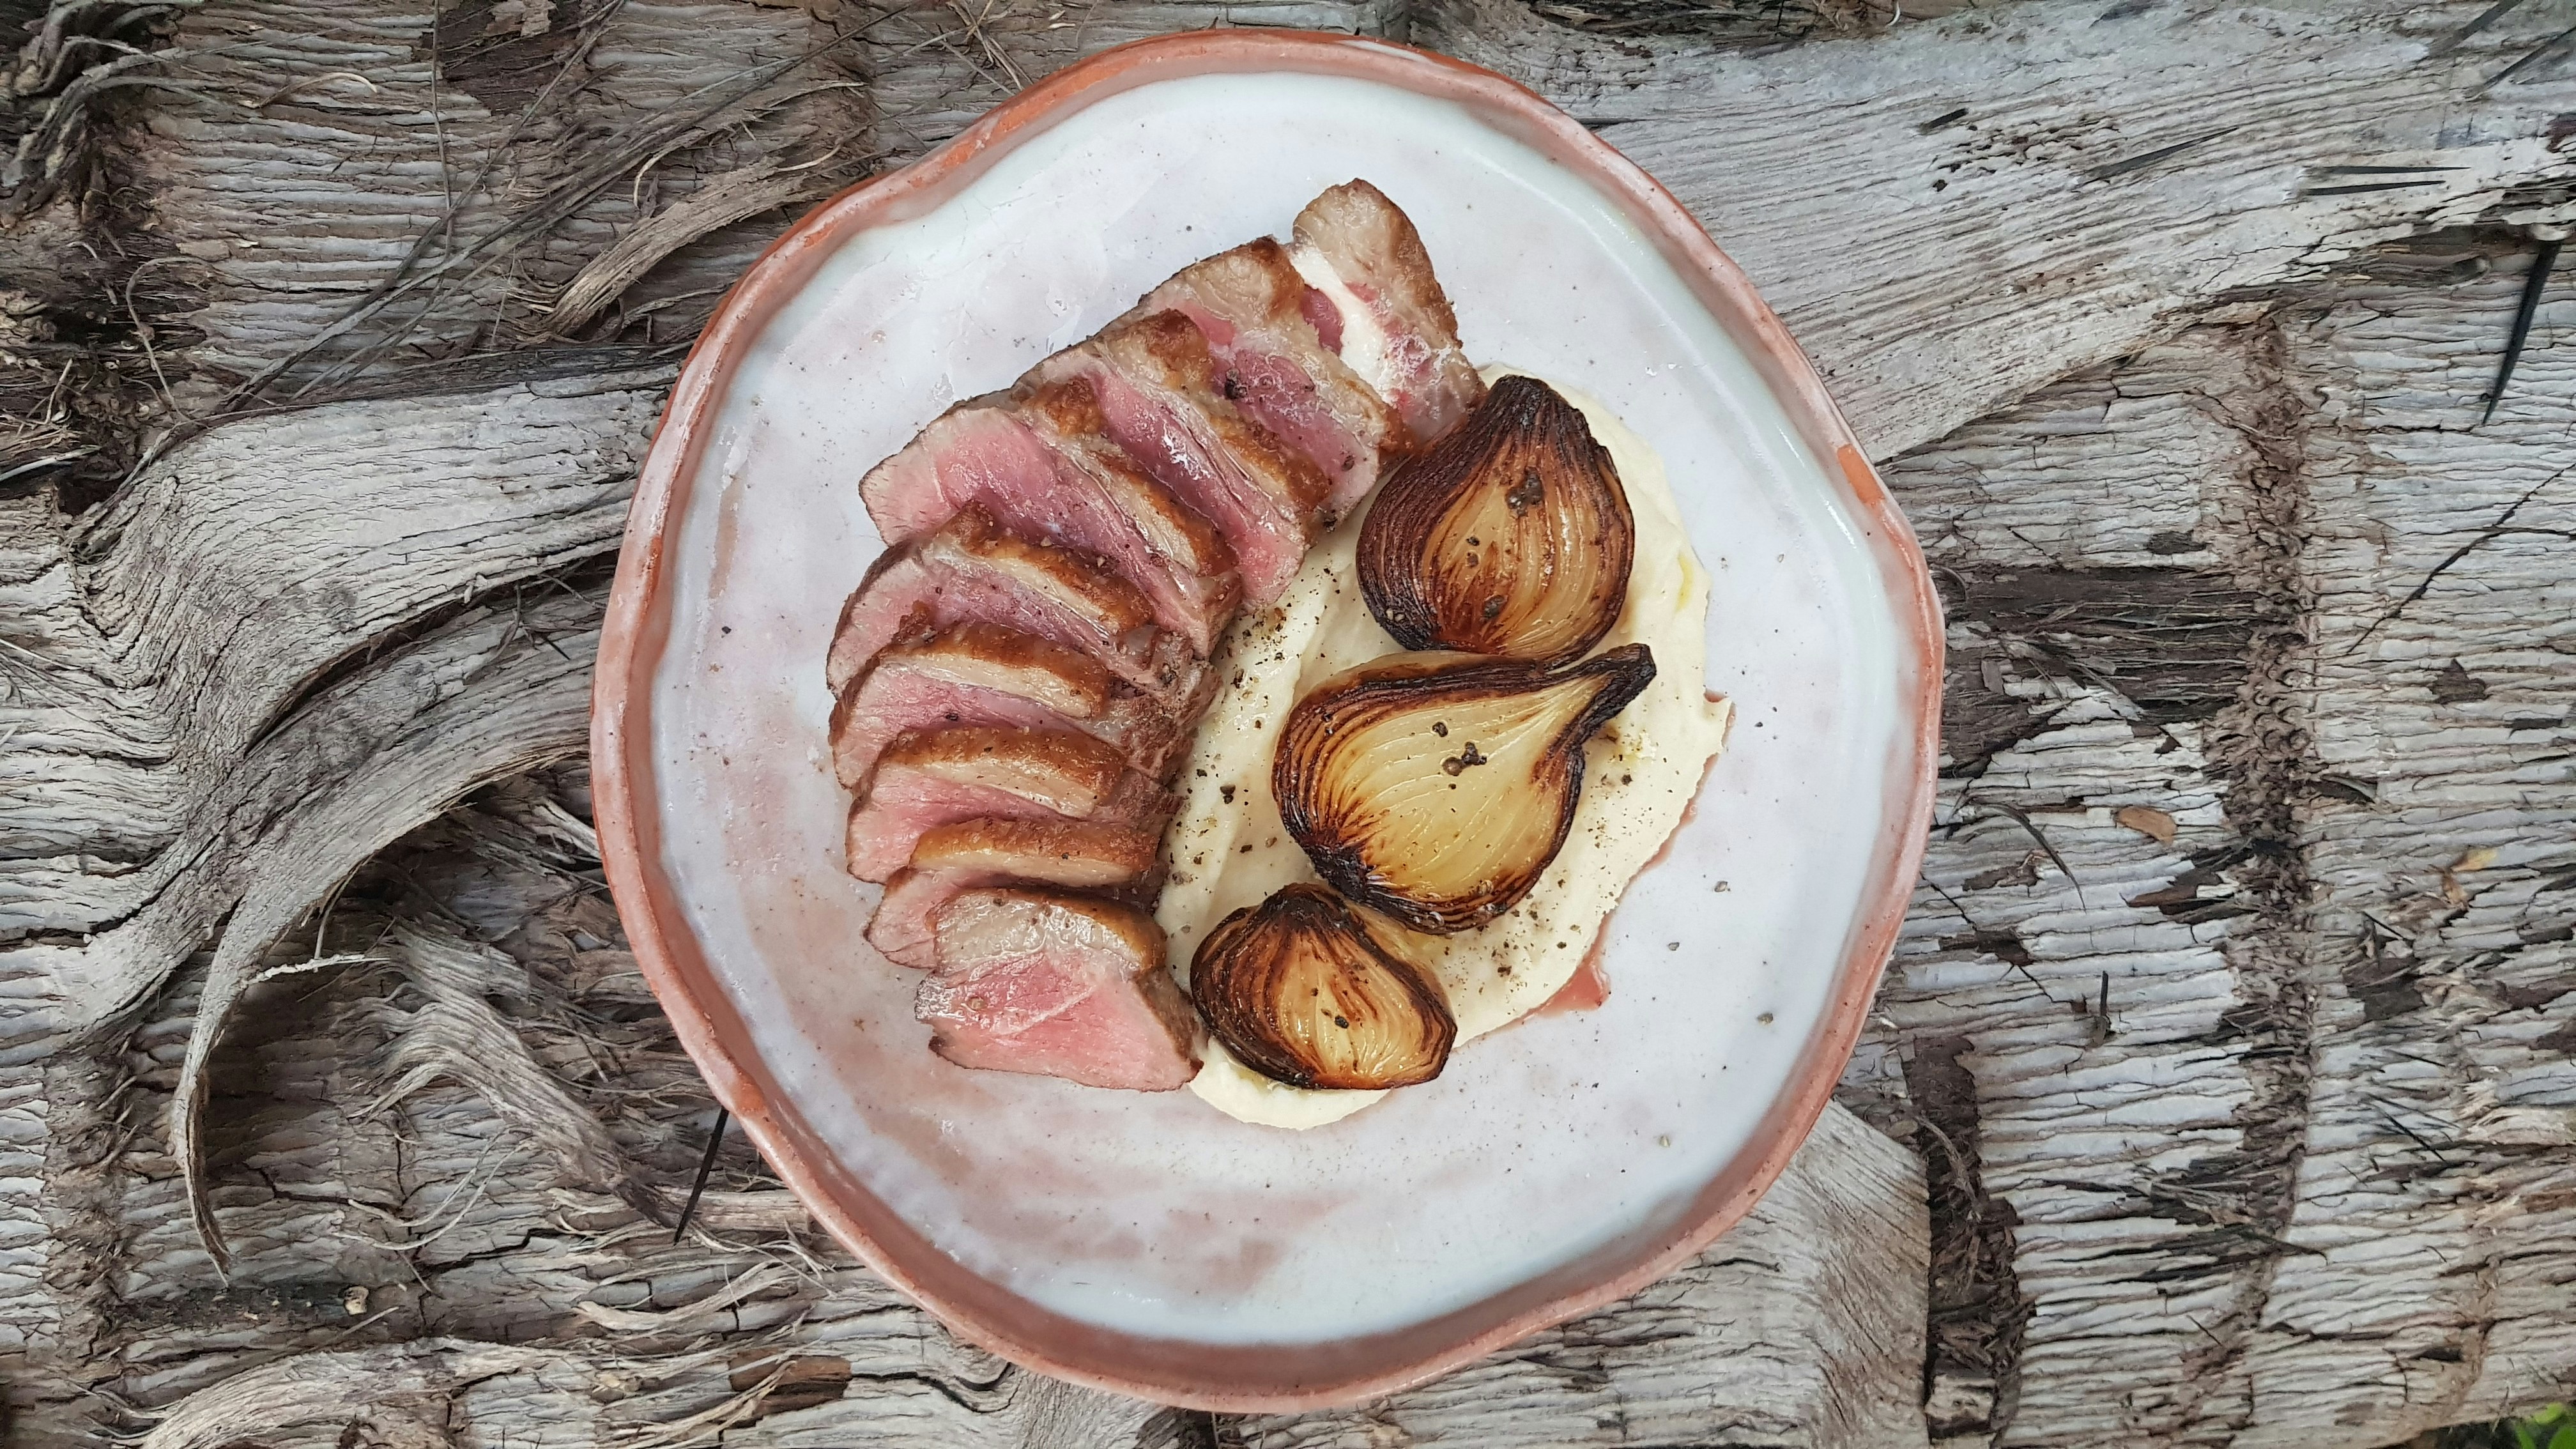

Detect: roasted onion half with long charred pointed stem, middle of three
1270,645,1654,936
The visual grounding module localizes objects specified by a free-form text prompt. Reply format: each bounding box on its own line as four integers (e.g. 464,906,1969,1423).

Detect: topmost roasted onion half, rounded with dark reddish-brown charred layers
1360,376,1636,663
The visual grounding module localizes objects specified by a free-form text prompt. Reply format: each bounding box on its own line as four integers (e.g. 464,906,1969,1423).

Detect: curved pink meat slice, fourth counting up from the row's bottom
832,619,1183,789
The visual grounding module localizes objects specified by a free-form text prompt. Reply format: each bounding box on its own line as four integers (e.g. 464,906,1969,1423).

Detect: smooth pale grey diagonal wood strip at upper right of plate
1412,0,2576,456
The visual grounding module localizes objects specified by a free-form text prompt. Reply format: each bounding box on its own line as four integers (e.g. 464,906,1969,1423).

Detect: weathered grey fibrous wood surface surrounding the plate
0,0,2576,1446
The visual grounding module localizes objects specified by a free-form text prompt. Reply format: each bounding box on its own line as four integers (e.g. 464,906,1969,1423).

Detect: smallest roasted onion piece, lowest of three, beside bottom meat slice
1190,884,1458,1091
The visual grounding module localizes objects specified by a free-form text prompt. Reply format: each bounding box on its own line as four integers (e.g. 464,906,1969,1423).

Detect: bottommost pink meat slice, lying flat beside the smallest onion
912,889,1200,1091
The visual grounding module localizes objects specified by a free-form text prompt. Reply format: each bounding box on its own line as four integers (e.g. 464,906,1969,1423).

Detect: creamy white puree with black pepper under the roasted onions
1154,366,1731,1130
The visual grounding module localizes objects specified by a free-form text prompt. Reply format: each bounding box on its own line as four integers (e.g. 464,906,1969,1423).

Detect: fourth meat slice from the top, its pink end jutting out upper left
858,397,1234,655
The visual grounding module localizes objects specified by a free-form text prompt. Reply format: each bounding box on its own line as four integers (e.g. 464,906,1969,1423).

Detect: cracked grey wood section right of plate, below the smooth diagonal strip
1847,237,2576,1444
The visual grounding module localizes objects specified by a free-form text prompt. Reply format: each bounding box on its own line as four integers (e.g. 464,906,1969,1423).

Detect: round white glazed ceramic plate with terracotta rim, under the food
592,31,1940,1410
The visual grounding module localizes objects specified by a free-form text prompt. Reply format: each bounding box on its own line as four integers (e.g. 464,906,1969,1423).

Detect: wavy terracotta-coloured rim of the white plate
590,28,1942,1413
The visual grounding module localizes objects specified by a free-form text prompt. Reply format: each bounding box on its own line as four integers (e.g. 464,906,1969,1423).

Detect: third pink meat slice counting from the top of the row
1028,312,1332,603
